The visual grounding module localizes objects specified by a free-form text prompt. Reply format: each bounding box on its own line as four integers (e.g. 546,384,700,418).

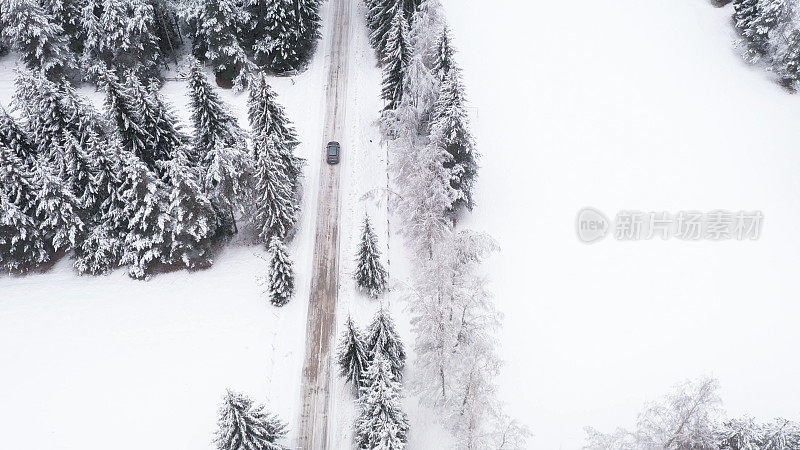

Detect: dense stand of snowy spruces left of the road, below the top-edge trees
0,62,304,286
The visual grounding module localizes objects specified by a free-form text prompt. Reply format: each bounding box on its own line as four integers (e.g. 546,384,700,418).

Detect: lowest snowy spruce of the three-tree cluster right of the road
356,351,409,450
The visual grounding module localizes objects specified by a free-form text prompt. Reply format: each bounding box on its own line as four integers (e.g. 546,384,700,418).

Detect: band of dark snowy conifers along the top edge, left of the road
0,0,321,86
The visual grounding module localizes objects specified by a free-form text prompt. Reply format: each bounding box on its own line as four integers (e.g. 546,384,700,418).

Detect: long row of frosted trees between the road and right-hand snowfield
366,0,528,449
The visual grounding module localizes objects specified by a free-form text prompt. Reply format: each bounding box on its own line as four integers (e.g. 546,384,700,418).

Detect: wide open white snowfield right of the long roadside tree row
444,0,800,449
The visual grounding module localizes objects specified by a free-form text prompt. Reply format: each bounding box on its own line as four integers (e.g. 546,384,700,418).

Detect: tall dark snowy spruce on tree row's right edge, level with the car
431,67,478,218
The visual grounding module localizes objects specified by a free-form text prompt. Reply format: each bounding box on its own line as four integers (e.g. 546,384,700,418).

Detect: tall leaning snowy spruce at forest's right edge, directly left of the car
247,73,304,197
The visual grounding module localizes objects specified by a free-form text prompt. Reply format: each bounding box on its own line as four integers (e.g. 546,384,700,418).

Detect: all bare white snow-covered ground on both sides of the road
0,0,800,450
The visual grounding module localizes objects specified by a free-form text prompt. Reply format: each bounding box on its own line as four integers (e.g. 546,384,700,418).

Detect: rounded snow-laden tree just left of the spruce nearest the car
203,145,253,236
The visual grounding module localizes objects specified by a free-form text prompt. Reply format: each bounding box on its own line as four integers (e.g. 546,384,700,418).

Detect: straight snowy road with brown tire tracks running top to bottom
298,0,352,450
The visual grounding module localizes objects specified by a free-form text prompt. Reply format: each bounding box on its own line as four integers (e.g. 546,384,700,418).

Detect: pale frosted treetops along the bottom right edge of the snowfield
583,378,800,450
